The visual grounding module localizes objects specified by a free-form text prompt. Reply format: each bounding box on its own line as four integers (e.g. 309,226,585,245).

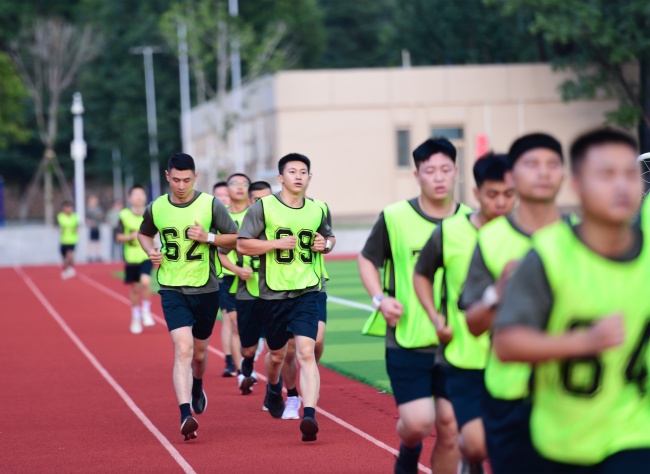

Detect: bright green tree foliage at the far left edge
0,53,29,149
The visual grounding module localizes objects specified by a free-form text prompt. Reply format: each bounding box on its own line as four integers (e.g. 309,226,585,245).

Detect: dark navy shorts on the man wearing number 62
158,290,219,340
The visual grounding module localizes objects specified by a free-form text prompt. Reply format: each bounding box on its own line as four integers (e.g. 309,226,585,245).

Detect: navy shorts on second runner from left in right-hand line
444,365,487,429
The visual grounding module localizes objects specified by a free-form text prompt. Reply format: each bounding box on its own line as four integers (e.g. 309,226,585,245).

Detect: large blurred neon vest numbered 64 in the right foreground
531,222,650,462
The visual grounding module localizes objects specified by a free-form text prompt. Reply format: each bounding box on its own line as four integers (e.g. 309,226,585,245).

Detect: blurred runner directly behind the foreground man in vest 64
459,133,564,474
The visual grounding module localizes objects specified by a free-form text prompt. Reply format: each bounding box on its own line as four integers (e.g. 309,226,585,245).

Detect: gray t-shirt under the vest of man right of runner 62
238,193,334,300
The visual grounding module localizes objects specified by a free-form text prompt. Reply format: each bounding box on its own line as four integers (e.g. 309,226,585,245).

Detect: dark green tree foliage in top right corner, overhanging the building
487,0,650,151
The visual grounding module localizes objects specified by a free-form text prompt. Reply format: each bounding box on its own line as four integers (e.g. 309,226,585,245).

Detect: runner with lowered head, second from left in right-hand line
413,153,515,473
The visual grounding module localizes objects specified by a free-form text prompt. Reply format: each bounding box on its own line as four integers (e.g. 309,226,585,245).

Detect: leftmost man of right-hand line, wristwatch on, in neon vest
359,138,471,473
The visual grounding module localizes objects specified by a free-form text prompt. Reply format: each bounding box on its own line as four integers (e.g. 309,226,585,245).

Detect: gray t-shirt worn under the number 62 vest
140,191,237,295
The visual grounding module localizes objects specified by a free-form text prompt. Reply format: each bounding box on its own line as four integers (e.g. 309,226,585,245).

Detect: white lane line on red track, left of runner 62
14,266,196,474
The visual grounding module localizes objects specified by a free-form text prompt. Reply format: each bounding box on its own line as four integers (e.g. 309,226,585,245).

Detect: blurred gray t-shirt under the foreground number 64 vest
494,226,643,331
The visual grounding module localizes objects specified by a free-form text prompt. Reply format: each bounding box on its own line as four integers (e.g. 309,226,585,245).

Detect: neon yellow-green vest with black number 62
151,193,215,287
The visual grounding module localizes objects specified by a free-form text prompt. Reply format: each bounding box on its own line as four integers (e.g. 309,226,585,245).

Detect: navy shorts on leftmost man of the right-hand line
386,348,448,405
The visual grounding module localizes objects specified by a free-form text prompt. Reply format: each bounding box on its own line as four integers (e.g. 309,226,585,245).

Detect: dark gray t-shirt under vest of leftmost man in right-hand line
361,198,460,354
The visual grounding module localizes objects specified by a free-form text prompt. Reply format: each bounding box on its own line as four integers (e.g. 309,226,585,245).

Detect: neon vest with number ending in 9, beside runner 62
260,194,323,291
